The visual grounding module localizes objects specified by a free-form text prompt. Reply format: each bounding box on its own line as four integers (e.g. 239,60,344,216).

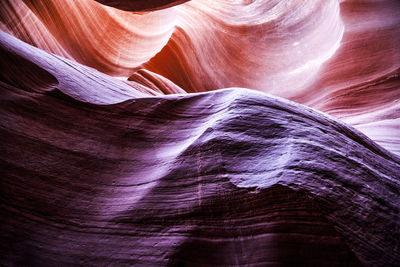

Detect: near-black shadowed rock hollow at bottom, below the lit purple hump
168,185,362,266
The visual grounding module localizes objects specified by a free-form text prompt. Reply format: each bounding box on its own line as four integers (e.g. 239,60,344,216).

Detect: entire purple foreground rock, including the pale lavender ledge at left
0,33,400,266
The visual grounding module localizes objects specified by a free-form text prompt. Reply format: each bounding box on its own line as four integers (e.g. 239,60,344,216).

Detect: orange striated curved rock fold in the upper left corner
0,0,175,77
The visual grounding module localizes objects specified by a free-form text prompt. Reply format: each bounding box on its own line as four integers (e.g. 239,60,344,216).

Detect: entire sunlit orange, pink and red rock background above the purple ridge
0,0,400,157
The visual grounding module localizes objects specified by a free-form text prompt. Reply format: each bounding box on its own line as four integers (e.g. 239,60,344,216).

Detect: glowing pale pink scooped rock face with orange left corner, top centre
145,0,343,96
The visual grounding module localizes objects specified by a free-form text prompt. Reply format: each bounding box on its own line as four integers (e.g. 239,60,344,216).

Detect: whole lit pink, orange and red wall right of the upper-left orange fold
144,0,400,154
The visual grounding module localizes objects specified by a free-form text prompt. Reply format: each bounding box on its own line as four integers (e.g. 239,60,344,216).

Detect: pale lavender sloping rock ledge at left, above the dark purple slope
0,31,159,104
